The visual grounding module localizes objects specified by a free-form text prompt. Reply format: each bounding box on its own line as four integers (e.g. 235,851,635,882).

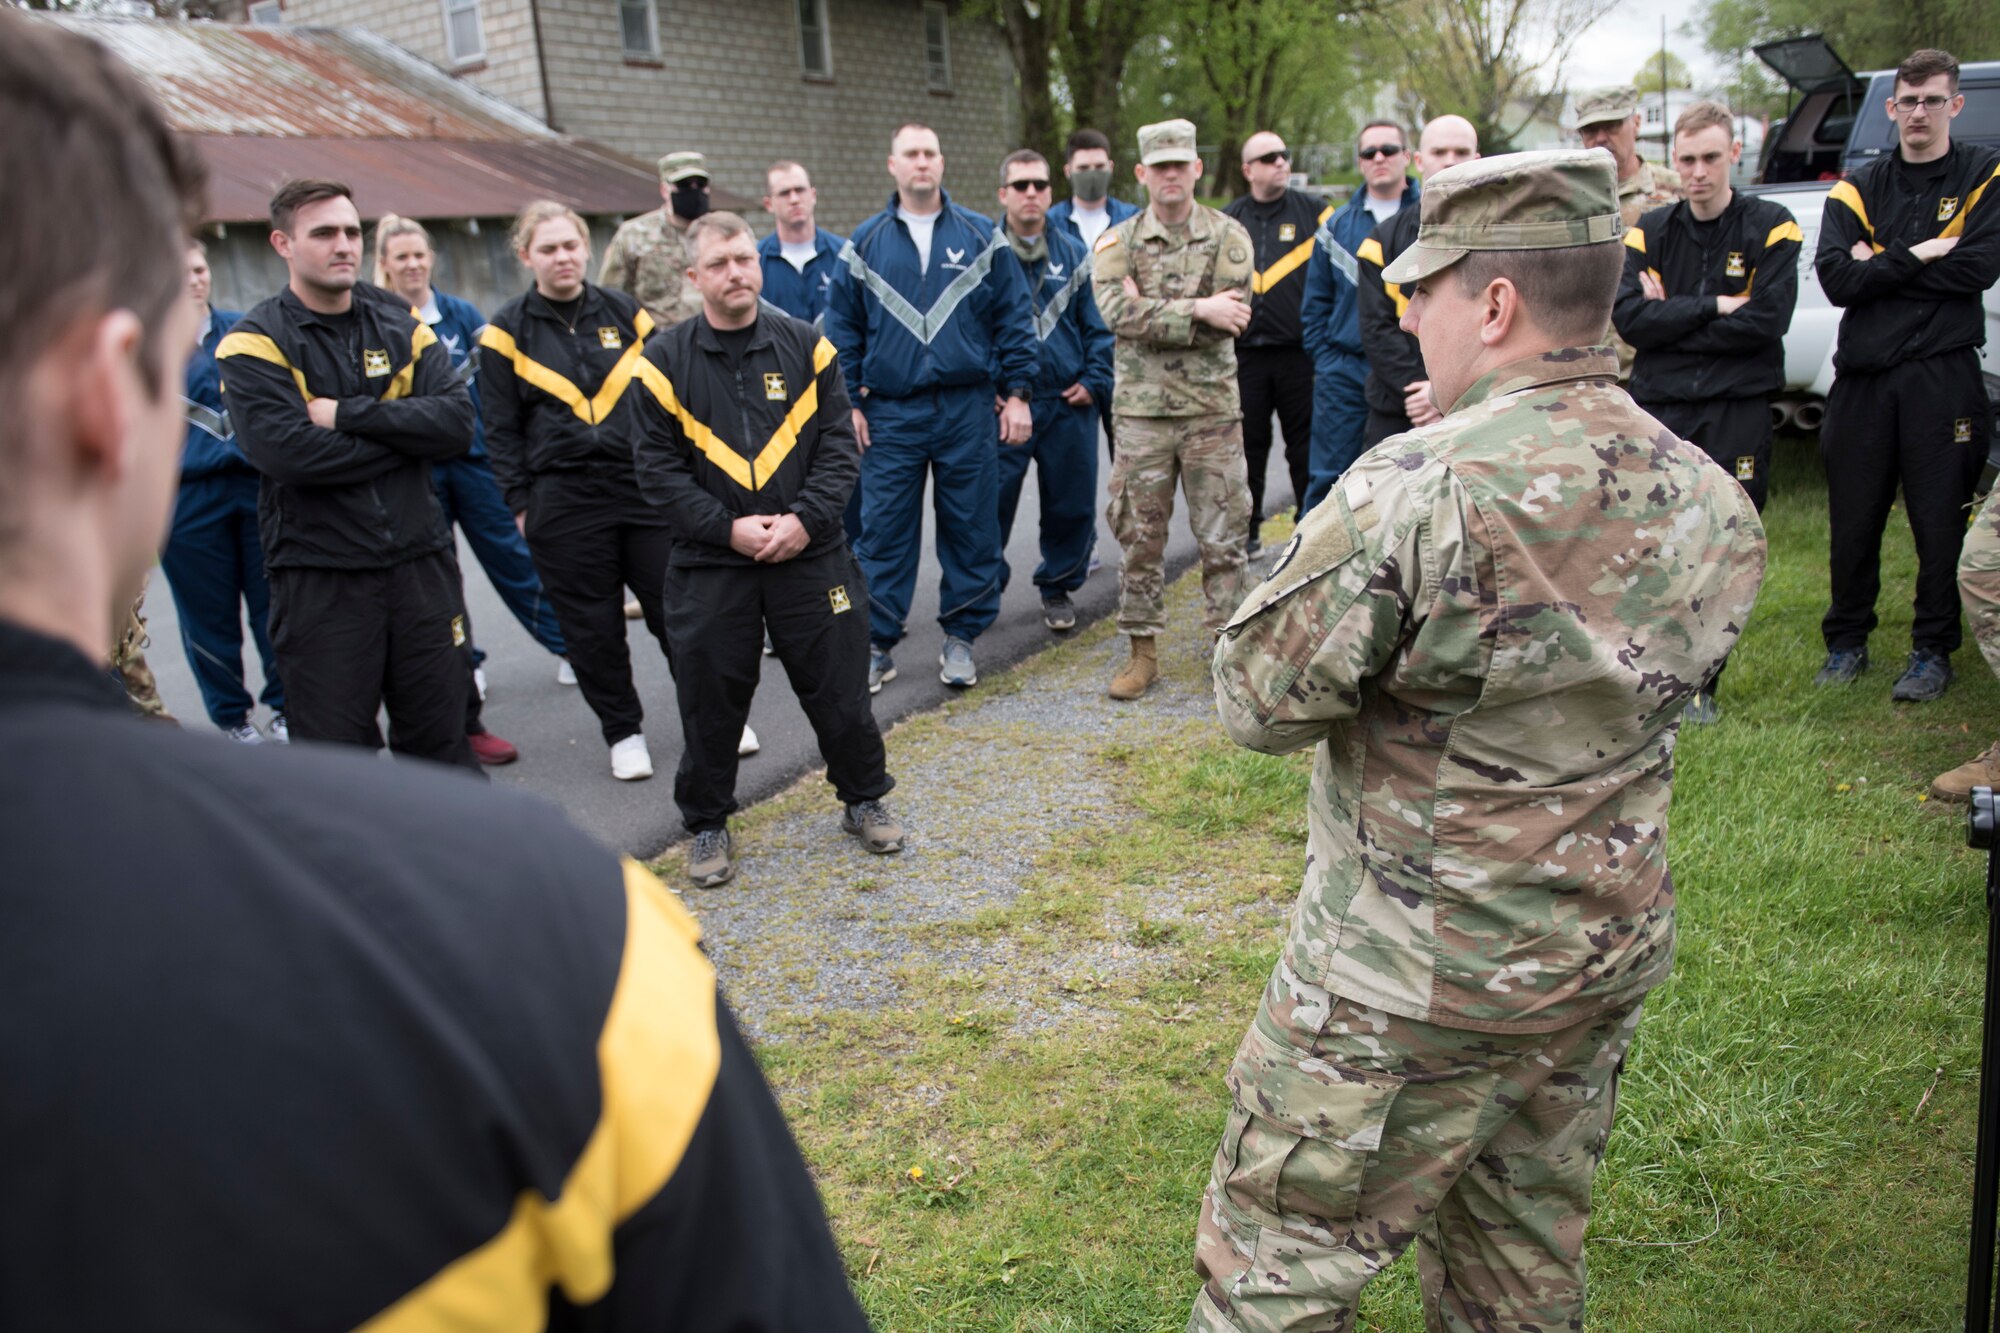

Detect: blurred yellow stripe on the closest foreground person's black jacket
362,861,722,1333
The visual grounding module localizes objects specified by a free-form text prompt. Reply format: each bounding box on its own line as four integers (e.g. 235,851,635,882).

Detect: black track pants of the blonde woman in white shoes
528,472,672,745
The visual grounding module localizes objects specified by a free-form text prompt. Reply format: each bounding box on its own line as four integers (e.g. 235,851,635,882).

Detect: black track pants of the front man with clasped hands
664,544,896,833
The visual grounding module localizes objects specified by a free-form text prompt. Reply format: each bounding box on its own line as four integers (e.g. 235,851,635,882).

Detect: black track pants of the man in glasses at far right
1824,348,1992,652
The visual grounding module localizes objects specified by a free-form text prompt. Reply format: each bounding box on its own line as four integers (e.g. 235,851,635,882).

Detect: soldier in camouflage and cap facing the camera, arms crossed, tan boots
1090,120,1252,699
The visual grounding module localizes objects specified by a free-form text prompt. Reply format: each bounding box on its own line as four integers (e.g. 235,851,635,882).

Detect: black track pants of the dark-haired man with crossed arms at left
270,552,480,771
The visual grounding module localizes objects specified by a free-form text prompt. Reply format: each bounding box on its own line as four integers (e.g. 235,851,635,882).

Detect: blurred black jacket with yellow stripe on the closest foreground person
0,616,868,1333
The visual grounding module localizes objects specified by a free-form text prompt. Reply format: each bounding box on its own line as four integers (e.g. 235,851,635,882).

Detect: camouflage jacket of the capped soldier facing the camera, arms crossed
1090,204,1254,416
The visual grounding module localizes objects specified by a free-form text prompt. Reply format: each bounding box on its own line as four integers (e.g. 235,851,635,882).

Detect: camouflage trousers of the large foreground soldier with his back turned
1184,960,1642,1333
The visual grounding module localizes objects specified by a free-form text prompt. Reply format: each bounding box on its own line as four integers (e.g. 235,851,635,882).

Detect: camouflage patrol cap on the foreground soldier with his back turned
1382,148,1624,282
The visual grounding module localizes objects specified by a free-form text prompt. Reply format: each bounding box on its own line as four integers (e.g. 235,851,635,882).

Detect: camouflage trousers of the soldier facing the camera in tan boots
1104,416,1250,634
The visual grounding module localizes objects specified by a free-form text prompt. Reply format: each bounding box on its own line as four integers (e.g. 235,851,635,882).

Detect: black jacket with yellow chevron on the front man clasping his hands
636,306,860,564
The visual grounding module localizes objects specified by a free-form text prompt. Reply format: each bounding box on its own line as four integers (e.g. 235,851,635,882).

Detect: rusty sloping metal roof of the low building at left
52,16,750,222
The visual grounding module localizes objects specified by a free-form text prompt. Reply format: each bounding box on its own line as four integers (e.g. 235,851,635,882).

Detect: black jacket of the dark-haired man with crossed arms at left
216,284,474,568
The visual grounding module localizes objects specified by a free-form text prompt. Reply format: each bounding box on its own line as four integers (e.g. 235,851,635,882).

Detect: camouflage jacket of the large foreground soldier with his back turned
1214,346,1764,1033
